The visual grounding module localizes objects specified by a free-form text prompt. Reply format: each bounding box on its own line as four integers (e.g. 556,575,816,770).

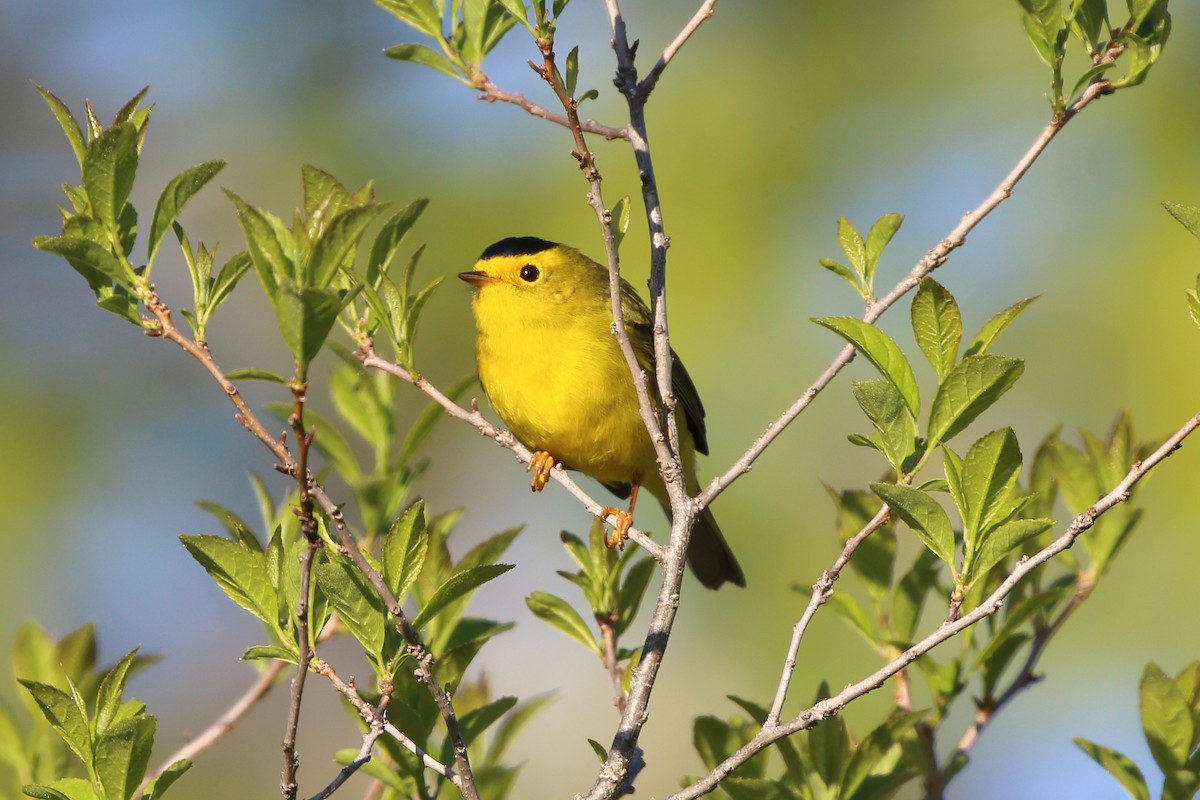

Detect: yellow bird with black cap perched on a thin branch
458,236,745,589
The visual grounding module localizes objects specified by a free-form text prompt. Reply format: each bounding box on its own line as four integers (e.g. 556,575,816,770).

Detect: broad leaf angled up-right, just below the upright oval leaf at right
928,354,1025,447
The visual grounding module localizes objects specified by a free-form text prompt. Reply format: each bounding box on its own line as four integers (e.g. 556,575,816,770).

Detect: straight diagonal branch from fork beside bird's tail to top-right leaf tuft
696,76,1109,507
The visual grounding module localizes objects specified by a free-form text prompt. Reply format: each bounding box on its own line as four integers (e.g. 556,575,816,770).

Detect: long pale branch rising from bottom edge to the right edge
668,413,1200,800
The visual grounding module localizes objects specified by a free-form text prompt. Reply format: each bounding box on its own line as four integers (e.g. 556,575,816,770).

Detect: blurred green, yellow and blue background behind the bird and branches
0,0,1200,800
